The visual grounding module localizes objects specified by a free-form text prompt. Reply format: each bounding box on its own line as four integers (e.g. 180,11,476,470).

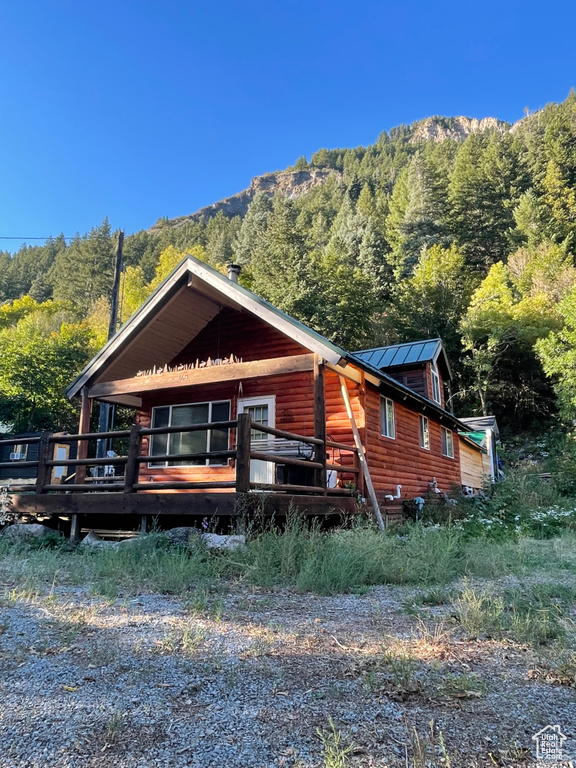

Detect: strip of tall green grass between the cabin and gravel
0,518,576,597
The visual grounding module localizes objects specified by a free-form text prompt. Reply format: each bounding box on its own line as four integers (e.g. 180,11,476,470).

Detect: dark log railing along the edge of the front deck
0,413,360,495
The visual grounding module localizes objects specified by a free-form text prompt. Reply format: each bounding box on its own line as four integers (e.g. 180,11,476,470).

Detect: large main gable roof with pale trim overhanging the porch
66,256,468,431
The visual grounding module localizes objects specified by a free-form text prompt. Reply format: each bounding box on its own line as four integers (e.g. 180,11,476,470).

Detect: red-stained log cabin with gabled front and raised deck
6,256,488,532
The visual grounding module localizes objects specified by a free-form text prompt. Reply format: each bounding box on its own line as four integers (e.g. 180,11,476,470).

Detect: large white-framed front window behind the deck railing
150,400,230,467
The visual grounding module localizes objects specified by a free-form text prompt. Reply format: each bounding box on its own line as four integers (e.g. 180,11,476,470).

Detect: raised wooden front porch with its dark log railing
0,413,362,535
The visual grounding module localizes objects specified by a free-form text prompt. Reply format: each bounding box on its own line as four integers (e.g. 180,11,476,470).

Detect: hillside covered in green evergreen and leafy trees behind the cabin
0,93,576,430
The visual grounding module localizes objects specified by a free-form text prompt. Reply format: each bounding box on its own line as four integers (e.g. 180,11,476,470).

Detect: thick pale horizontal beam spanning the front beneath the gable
89,354,314,398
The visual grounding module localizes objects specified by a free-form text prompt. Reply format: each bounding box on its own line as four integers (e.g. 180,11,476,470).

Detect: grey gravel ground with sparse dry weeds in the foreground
0,585,576,768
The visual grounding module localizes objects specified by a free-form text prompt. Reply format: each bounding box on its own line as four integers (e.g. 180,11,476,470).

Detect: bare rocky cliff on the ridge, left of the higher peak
149,168,342,232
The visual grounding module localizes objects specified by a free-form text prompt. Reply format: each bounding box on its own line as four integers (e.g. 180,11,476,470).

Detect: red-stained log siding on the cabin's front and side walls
130,309,461,499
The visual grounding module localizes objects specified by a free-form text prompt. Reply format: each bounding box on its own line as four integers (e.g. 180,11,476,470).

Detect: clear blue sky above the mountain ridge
0,0,576,250
